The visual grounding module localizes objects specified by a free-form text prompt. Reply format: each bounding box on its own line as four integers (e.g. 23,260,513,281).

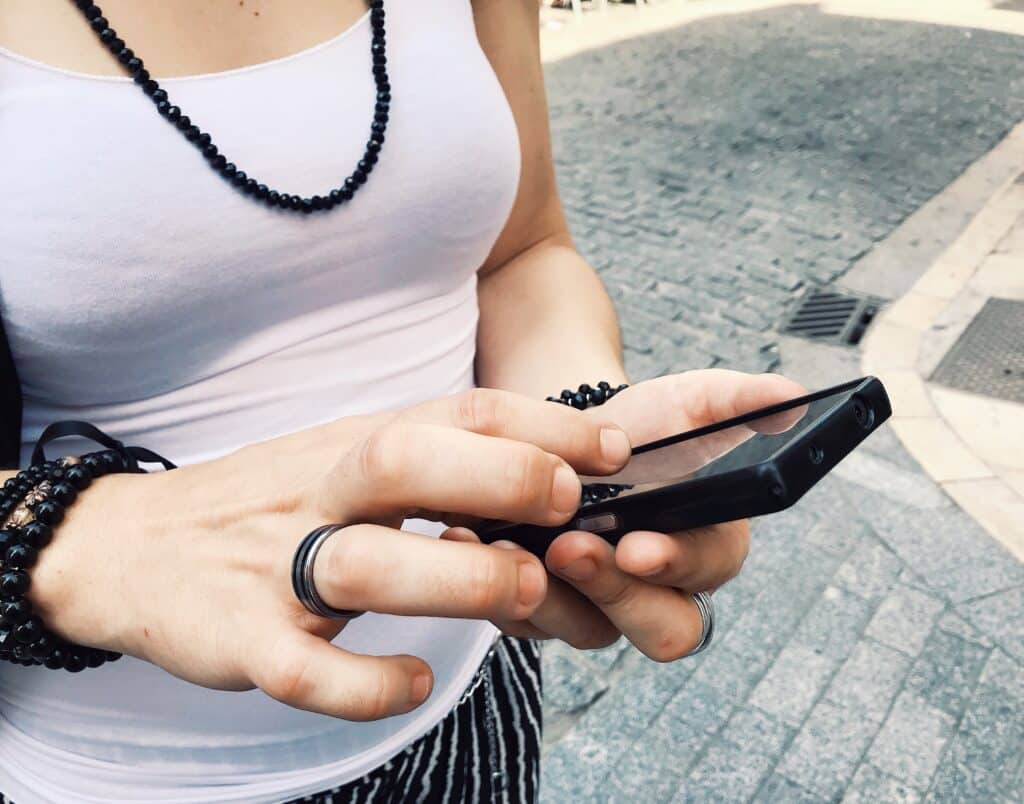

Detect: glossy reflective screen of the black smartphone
581,380,873,502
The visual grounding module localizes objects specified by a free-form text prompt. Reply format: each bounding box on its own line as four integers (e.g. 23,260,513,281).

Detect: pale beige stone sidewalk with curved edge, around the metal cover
862,135,1024,561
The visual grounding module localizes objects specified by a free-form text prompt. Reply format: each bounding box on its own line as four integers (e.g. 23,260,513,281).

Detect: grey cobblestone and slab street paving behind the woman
543,7,1024,804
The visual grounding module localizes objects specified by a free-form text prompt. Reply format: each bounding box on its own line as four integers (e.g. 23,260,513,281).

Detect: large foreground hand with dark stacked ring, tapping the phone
31,390,630,720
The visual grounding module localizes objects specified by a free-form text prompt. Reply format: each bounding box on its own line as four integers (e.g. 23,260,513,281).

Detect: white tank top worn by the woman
0,0,519,804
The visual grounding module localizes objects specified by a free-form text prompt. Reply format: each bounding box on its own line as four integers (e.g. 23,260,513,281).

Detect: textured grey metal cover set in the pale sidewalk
932,299,1024,403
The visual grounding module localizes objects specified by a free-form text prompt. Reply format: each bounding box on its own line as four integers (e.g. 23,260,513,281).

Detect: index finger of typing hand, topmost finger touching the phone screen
401,388,631,475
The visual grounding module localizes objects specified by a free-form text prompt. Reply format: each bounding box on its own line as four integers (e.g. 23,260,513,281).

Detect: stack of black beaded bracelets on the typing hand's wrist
0,450,137,673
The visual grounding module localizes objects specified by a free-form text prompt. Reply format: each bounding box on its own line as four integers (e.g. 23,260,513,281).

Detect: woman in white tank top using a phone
0,0,799,804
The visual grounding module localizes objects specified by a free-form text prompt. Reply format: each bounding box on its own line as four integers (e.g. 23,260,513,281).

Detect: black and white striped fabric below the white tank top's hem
0,637,543,804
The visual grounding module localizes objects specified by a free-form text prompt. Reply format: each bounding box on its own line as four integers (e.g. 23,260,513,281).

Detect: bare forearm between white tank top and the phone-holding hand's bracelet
476,237,628,397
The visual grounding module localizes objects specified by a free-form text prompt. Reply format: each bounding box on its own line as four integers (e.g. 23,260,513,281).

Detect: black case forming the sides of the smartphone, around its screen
477,377,892,559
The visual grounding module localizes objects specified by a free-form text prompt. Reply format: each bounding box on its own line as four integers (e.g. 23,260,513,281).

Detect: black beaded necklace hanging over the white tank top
74,0,391,213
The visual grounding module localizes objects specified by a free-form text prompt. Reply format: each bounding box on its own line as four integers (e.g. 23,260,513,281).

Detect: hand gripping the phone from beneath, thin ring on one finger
449,370,806,662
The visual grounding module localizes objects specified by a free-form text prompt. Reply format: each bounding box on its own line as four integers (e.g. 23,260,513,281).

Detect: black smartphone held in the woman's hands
477,377,892,559
